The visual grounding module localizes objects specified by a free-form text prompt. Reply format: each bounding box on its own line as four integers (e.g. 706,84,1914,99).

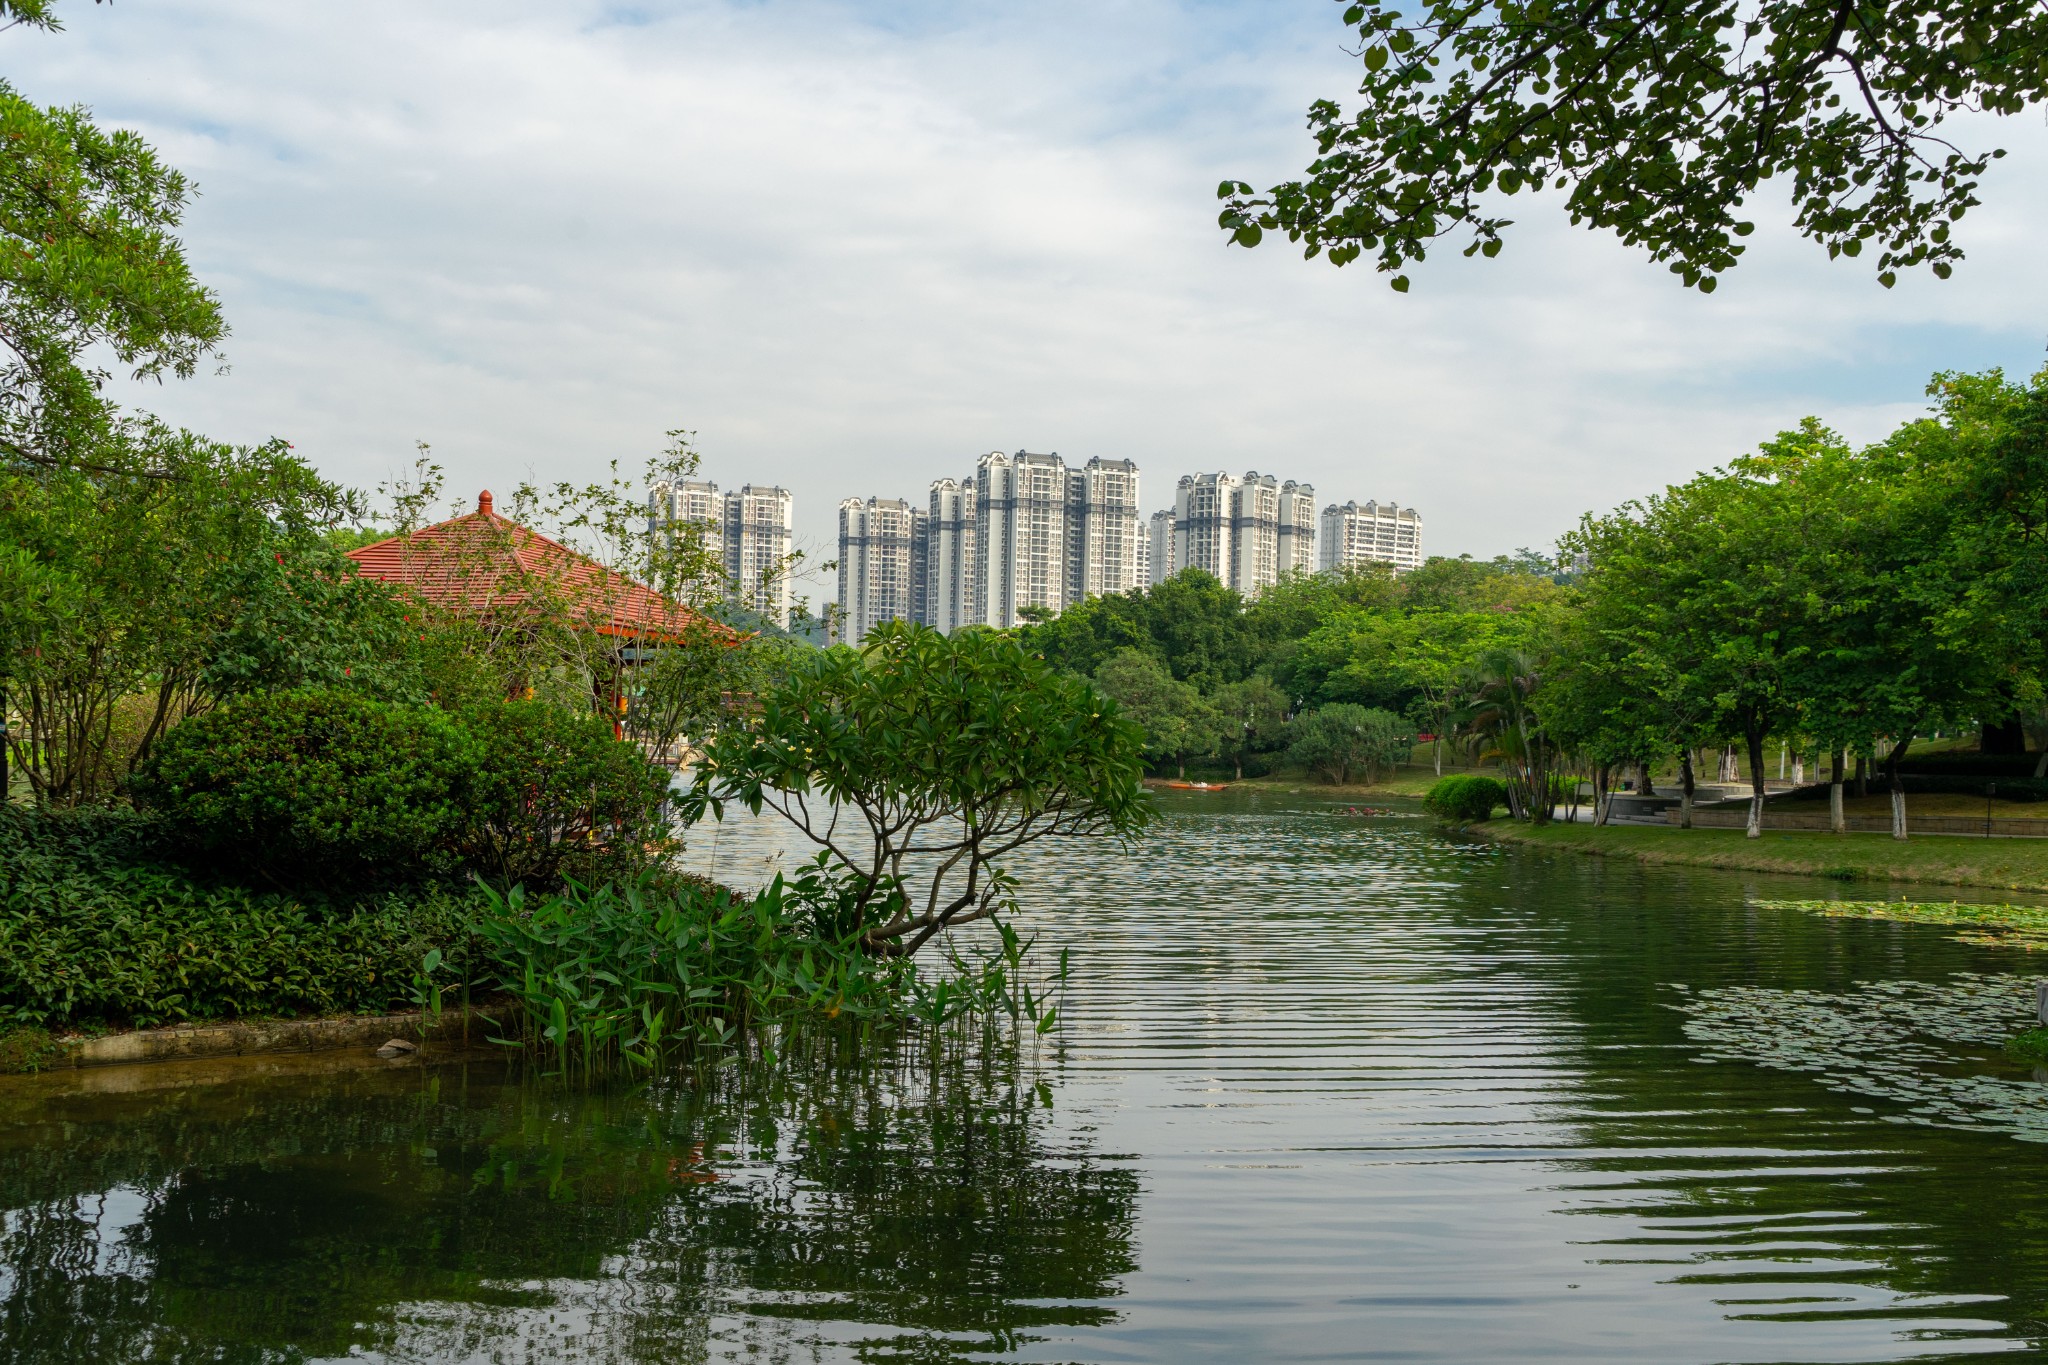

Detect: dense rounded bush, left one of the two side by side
133,692,475,884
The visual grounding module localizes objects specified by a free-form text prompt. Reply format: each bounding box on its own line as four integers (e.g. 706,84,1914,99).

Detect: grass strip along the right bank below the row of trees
1473,819,2048,890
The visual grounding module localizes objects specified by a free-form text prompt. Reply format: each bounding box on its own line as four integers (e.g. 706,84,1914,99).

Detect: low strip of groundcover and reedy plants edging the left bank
0,808,1065,1072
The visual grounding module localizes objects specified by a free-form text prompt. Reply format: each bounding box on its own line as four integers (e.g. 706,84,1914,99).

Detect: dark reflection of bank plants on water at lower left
0,1036,1137,1363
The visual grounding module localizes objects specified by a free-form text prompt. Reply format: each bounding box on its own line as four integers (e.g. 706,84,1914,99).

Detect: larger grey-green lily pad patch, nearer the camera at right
1675,970,2048,1142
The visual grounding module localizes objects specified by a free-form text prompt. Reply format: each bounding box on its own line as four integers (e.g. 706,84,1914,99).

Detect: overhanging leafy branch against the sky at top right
1219,0,2048,293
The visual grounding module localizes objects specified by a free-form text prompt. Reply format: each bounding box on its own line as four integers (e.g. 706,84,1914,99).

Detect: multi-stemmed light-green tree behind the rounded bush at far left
0,420,395,806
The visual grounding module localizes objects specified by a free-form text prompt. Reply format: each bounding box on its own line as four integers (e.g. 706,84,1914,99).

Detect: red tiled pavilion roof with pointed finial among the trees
348,491,739,641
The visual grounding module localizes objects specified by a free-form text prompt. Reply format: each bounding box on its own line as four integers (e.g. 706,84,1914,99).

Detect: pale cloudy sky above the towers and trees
0,0,2048,597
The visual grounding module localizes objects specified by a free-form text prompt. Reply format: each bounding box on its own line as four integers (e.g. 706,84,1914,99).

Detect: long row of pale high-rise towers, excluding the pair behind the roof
836,450,1421,641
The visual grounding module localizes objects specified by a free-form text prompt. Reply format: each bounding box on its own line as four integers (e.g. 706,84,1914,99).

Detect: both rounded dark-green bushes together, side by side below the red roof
133,692,668,888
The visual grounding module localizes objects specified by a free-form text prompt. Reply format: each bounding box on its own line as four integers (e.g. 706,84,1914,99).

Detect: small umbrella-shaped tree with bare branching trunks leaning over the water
682,622,1151,958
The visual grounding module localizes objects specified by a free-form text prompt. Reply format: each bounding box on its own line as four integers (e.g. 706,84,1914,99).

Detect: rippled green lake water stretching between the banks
0,792,2048,1365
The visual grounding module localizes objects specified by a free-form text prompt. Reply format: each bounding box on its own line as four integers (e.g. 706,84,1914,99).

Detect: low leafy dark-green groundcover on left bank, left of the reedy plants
0,808,479,1029
